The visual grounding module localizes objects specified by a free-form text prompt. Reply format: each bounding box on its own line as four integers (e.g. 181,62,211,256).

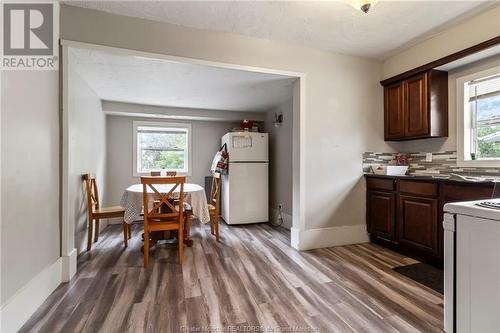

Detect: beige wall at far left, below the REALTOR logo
0,71,60,304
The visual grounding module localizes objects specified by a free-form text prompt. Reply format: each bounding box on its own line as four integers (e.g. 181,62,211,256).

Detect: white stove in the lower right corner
443,199,500,333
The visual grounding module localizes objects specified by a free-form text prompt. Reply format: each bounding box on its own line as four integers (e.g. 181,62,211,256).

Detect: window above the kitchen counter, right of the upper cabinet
457,68,500,167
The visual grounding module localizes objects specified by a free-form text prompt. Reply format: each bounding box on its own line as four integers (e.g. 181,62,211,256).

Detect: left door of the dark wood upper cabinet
384,82,405,140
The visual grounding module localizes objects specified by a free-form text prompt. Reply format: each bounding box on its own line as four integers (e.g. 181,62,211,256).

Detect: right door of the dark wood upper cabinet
403,73,430,137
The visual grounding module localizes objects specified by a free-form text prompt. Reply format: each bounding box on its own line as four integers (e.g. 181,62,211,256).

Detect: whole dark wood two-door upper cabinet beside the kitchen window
384,70,448,141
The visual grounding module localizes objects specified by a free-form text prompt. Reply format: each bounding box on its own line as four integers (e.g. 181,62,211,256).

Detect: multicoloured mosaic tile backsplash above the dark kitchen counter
363,151,500,175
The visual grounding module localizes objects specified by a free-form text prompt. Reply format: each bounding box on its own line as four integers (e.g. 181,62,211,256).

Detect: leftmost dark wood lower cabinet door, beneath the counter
366,191,395,241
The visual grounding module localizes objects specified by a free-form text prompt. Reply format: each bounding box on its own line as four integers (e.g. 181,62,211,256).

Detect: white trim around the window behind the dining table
132,121,193,177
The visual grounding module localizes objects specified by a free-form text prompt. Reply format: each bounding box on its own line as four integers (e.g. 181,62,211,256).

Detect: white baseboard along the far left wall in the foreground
0,257,63,333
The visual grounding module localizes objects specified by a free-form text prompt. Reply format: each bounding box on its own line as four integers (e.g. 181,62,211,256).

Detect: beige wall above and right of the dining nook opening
61,6,391,229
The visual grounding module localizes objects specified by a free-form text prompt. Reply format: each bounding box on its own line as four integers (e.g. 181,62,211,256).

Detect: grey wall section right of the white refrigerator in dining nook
264,100,293,216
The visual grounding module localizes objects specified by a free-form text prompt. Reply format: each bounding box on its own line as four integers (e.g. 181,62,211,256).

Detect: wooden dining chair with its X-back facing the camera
141,177,186,267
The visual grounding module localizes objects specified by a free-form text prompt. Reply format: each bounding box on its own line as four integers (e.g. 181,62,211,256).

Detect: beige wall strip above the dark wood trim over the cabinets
383,5,500,79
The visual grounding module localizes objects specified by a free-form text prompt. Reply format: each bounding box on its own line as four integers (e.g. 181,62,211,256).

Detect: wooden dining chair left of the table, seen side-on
83,173,131,251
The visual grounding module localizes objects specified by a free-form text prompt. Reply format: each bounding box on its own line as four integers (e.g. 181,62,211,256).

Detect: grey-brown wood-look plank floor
21,223,443,332
